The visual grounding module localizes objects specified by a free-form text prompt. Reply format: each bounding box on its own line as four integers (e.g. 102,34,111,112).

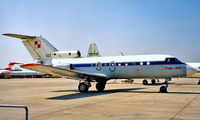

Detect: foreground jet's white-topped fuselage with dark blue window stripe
52,55,191,79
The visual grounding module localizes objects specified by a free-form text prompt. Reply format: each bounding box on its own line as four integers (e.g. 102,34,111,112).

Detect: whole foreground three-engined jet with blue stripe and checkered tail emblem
3,33,200,92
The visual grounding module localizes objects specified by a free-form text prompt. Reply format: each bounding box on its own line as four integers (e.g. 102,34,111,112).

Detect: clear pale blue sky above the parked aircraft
0,0,200,68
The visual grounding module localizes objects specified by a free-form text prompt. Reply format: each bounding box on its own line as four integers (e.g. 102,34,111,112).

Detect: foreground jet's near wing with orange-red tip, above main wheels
21,64,107,80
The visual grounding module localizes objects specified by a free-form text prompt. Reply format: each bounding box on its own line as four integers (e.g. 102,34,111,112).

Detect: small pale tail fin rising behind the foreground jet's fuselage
87,43,101,57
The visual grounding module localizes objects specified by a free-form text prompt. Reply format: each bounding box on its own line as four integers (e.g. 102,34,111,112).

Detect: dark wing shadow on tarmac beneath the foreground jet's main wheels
47,88,145,100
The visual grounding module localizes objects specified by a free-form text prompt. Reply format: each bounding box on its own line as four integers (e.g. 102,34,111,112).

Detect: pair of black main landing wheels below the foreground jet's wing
78,80,106,93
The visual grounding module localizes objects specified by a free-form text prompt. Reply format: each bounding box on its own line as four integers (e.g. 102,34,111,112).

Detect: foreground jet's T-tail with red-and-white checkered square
3,33,58,65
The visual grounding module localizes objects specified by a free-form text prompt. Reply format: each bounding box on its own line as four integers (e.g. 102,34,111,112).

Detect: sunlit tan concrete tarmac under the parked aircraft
0,78,200,120
